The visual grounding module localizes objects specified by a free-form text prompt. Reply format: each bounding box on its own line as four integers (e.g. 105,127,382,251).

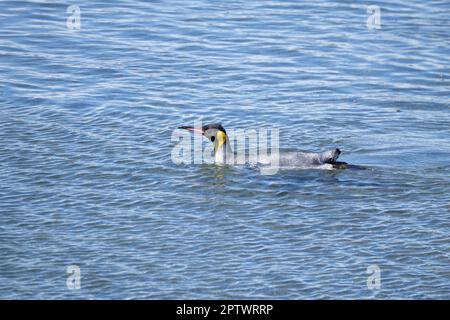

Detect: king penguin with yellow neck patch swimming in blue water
178,123,347,169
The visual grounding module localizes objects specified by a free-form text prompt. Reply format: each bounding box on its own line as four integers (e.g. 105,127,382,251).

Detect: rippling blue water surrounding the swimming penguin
0,0,450,299
